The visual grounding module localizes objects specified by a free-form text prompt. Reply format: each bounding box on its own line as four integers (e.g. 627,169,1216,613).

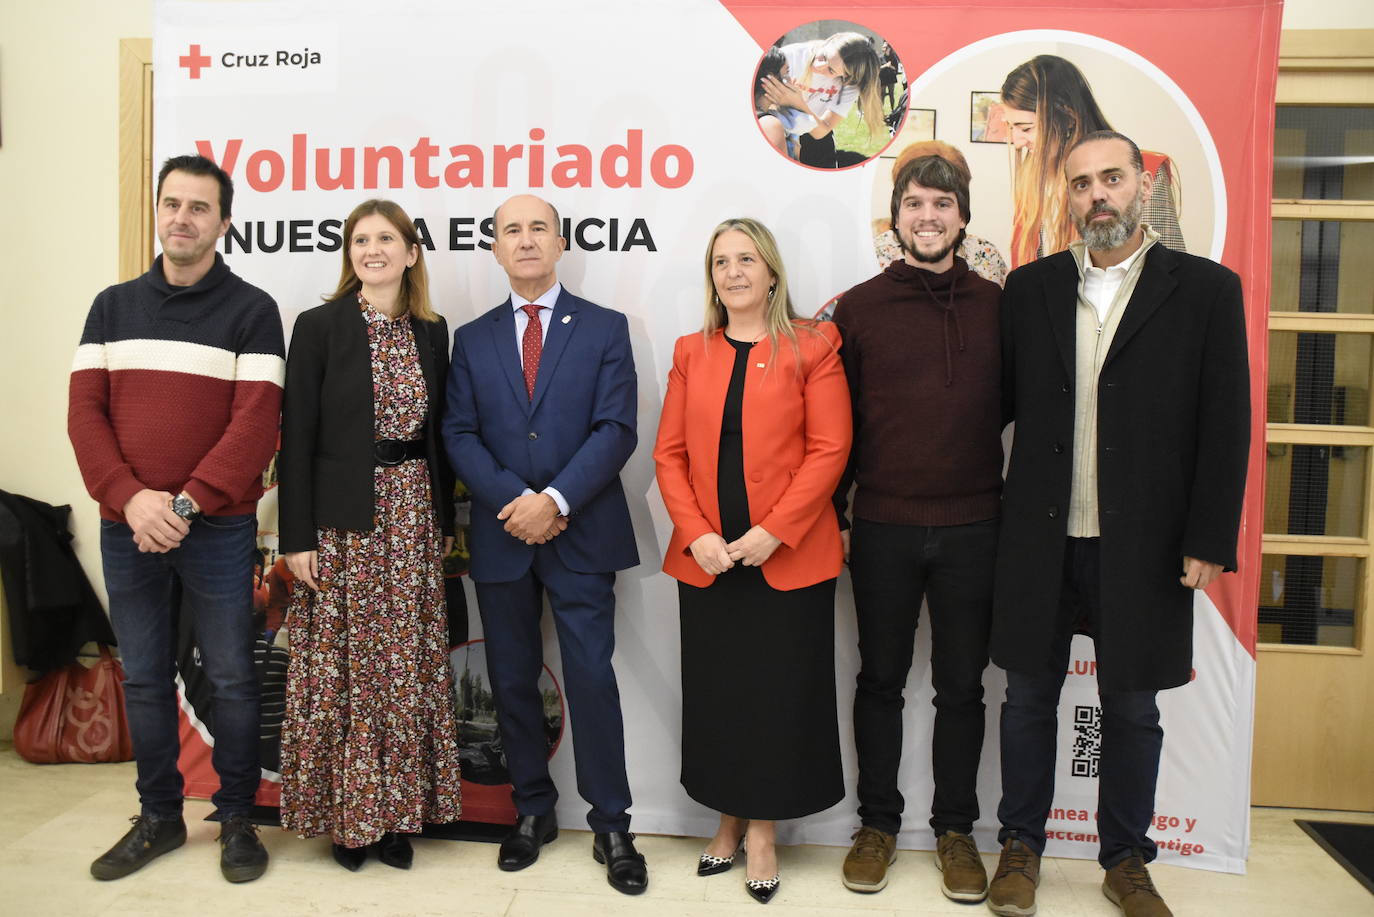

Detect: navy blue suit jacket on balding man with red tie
444,287,639,583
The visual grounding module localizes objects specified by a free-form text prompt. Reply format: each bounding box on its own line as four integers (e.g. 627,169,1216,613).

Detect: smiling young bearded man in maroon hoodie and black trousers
834,155,1002,902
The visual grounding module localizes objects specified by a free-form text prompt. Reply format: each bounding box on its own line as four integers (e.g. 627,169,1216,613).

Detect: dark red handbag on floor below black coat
14,643,133,764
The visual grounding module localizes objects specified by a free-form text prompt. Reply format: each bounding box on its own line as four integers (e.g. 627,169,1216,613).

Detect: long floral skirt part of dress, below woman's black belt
282,459,460,847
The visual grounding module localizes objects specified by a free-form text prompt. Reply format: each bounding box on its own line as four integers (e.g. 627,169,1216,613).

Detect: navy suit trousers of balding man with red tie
475,544,631,832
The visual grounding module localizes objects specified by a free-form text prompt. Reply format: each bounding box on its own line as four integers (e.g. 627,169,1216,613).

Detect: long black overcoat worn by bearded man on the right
991,243,1250,690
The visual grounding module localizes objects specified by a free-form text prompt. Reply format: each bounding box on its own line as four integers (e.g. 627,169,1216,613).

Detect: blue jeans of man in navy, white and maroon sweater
100,516,260,818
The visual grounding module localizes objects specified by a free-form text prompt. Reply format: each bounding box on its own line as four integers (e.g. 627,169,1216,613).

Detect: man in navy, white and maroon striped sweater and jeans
67,157,284,881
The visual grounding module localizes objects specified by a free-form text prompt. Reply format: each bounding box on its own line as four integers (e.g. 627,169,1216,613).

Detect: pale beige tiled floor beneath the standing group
0,745,1374,917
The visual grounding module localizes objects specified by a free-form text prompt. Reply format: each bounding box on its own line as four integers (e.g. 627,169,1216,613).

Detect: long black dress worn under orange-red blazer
677,337,845,819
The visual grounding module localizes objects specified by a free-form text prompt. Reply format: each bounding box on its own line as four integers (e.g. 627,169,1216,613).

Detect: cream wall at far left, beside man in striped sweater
0,0,153,737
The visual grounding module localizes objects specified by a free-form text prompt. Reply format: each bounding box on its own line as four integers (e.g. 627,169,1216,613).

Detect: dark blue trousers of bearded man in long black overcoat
998,538,1164,869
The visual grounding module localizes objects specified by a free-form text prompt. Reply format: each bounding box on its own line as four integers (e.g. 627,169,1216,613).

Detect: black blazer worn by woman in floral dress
278,296,453,553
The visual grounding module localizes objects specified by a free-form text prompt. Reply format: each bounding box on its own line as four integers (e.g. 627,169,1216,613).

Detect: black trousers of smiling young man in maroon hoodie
849,520,998,837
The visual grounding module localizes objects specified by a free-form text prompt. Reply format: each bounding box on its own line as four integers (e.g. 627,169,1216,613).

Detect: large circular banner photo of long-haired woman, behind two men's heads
870,33,1226,285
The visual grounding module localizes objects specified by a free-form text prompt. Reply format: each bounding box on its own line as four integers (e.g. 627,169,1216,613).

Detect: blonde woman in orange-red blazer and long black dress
654,219,852,902
